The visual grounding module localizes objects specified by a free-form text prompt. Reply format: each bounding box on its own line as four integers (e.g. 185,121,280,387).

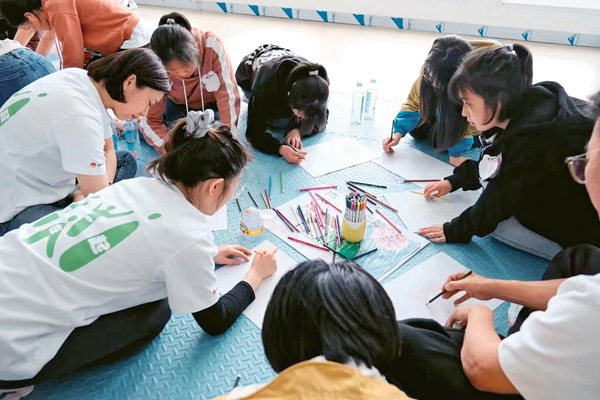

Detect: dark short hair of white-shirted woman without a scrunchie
88,49,171,103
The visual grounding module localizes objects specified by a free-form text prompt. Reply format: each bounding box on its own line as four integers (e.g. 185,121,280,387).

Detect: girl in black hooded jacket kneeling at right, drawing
419,44,600,258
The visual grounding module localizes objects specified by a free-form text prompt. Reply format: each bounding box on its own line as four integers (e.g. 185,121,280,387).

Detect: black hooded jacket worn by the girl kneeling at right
444,82,600,247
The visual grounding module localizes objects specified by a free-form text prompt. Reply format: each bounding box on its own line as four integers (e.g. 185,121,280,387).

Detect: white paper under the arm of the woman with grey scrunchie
215,241,297,329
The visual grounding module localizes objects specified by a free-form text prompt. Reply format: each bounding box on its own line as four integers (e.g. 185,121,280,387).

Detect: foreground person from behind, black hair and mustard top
219,260,409,400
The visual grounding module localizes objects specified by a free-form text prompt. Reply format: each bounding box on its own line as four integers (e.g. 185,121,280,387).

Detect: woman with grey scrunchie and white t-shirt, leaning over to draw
0,110,277,394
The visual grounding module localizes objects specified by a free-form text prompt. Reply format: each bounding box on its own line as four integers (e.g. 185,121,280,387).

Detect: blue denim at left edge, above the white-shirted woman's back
0,48,56,106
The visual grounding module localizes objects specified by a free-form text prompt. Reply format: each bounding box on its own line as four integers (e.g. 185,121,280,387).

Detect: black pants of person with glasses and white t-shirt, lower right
386,245,600,400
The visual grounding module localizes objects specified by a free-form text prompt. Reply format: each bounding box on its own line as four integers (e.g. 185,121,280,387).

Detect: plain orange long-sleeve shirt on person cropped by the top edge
42,0,140,68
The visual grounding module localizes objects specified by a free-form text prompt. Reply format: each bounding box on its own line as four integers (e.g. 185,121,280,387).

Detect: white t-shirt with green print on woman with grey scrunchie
0,178,219,380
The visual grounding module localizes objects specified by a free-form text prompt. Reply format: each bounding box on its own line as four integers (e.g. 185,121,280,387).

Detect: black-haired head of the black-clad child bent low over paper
286,62,329,135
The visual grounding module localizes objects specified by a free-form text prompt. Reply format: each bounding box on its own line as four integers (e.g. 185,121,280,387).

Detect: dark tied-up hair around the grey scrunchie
147,118,252,195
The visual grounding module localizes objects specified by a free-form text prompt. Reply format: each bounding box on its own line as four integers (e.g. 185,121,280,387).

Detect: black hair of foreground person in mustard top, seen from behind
262,260,401,374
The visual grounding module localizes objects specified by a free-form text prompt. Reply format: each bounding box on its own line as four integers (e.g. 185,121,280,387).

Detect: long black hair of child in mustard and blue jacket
415,35,473,151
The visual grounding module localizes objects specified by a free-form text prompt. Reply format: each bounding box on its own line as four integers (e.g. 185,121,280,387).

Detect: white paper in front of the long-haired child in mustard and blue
373,142,454,187
